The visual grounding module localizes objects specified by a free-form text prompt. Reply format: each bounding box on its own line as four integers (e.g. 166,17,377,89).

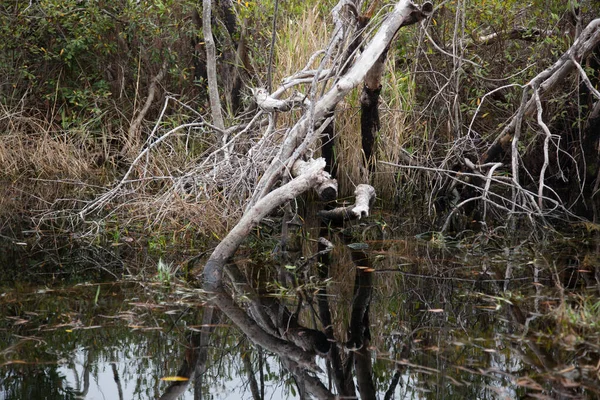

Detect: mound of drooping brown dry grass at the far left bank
0,109,100,231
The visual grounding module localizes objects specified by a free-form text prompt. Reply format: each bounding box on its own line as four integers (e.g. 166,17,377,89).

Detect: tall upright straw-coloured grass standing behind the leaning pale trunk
274,0,412,199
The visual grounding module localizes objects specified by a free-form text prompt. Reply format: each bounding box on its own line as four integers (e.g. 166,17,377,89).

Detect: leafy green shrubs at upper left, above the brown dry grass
0,0,195,128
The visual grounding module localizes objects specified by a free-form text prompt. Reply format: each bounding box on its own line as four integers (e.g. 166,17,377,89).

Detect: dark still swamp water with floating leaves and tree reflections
0,220,600,400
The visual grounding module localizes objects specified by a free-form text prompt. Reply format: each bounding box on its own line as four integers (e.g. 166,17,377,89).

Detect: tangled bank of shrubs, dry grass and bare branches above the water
0,0,600,245
